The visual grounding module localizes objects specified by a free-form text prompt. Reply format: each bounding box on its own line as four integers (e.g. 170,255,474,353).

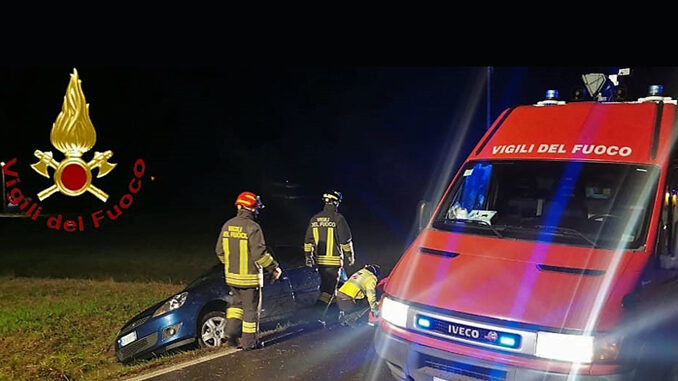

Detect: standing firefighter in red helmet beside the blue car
216,192,282,350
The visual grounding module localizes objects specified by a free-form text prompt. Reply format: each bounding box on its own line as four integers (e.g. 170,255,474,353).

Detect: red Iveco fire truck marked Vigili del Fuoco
375,72,678,380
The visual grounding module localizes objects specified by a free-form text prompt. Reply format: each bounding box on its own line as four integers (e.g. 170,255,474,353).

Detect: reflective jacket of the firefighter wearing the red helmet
216,209,278,288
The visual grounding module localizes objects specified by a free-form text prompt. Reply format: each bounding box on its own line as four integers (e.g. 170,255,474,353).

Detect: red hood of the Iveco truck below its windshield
385,230,643,330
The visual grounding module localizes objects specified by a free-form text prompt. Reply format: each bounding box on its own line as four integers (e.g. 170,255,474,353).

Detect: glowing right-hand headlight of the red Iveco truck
535,332,593,363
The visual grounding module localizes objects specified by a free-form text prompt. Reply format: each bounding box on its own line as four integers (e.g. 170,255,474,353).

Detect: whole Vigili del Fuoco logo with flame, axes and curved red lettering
0,69,154,233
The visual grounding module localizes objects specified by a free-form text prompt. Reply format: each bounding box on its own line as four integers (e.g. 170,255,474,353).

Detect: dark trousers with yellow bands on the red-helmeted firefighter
226,287,261,349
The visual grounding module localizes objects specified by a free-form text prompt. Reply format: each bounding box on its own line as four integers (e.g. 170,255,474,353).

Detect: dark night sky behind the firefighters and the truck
0,67,678,270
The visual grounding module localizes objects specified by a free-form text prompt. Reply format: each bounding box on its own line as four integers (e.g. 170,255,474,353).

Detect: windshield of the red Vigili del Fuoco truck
433,161,659,249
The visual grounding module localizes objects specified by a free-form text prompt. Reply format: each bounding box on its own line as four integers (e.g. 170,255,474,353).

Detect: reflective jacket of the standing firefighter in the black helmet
304,204,354,267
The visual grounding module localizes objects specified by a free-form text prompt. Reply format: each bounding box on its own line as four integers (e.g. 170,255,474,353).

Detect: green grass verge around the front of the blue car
0,277,300,380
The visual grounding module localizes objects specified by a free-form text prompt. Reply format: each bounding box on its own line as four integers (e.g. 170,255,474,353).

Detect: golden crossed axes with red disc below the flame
31,150,117,202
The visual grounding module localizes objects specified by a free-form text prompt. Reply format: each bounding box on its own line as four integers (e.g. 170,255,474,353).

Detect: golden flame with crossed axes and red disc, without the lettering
31,69,117,202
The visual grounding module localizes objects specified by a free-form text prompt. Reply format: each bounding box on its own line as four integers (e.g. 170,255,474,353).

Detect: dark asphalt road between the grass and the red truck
151,325,392,381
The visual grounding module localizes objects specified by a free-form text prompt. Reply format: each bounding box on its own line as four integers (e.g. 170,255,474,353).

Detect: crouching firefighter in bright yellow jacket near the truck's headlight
337,265,381,316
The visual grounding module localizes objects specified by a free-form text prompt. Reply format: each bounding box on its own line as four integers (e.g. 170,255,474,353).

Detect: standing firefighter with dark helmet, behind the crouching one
304,190,355,306
